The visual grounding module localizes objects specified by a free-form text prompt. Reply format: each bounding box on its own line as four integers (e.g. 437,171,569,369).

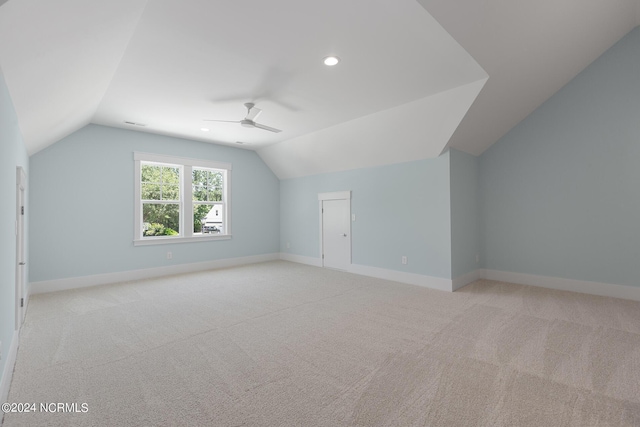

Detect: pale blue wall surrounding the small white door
280,152,451,279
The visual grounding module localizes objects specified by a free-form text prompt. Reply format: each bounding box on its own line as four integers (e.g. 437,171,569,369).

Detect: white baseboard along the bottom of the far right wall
481,270,640,301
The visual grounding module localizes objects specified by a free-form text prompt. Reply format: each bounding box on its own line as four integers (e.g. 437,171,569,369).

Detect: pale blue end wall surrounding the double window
30,125,279,282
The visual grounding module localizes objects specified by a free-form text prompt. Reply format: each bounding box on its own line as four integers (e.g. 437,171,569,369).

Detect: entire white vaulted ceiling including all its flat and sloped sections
0,0,640,178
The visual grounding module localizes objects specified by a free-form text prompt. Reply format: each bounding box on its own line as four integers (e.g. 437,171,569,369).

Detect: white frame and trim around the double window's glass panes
133,152,231,246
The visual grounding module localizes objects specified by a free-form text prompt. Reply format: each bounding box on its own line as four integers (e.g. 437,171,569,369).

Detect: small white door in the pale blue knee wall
322,199,351,270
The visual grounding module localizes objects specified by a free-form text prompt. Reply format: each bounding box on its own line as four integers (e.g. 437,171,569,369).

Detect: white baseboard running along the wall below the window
30,253,280,294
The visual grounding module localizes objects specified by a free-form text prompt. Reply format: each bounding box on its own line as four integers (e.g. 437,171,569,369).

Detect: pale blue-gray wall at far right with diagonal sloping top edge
480,28,640,286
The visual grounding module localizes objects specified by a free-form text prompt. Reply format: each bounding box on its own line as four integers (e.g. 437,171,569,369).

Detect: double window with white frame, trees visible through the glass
134,153,231,245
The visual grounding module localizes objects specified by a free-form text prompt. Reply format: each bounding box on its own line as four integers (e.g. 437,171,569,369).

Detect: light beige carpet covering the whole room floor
4,262,640,427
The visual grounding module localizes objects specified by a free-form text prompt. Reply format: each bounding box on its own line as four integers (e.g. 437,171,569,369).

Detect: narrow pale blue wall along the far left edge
0,73,30,390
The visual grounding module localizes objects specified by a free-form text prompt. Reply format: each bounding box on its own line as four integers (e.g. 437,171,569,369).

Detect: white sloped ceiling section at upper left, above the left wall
0,0,147,154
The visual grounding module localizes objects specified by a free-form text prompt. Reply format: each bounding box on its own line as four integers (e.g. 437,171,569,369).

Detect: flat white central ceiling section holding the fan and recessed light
93,0,486,156
